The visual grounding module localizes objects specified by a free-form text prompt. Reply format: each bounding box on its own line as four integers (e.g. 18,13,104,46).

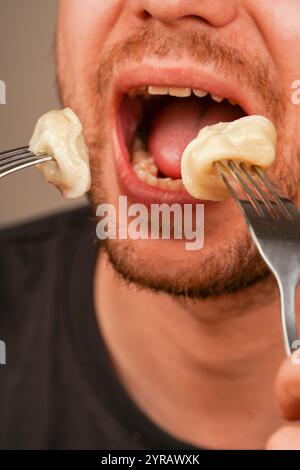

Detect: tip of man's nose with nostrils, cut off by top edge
136,0,238,27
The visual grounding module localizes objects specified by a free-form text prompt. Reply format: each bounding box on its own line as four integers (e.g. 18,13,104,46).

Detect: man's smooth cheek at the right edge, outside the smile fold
249,0,300,171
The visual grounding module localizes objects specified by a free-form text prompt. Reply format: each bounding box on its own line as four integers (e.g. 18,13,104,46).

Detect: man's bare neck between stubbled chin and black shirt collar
95,255,284,449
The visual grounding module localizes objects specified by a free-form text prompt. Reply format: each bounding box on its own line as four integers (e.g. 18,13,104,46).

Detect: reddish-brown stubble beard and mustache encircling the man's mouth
59,26,299,299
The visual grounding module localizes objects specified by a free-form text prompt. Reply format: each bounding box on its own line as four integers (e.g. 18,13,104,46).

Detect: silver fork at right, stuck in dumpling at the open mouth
216,160,300,356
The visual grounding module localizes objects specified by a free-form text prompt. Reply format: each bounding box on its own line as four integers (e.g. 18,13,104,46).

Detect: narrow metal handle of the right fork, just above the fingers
276,276,300,356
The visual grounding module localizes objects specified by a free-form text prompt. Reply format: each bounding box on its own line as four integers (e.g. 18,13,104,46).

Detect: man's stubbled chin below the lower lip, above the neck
92,186,268,299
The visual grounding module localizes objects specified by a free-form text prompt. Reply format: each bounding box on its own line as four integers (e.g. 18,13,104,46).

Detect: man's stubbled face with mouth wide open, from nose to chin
57,0,300,297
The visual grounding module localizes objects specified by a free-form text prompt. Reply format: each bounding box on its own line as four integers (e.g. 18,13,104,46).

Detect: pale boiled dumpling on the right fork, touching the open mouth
181,115,276,201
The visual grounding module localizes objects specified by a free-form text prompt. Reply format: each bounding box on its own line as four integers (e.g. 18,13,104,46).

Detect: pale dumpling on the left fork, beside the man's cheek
29,108,91,199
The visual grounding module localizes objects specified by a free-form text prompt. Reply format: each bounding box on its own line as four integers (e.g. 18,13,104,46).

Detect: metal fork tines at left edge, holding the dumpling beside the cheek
0,147,53,178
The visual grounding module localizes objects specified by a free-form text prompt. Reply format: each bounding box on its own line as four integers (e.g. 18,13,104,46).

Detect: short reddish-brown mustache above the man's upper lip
97,24,285,122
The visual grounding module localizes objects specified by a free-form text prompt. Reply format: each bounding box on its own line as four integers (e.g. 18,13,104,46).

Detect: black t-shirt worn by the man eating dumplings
0,208,197,450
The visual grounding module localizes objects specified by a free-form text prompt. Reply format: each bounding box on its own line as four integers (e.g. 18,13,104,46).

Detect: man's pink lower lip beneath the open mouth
113,108,218,206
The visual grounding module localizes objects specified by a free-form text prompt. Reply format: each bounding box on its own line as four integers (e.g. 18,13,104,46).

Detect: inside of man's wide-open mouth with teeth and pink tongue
115,77,246,201
